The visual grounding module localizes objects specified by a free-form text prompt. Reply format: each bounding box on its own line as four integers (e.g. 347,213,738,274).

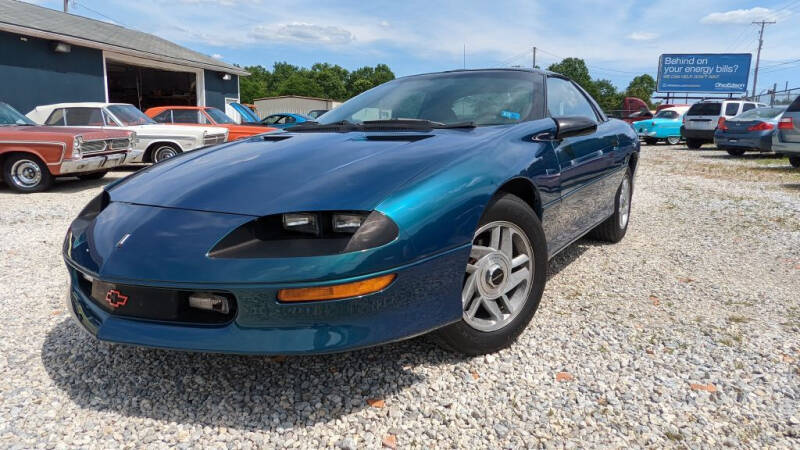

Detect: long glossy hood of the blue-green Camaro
109,127,500,216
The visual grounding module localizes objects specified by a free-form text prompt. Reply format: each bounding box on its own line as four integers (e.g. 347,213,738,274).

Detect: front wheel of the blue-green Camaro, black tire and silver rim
433,194,547,355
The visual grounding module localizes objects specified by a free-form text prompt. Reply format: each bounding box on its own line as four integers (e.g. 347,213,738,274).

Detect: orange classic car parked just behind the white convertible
144,106,277,141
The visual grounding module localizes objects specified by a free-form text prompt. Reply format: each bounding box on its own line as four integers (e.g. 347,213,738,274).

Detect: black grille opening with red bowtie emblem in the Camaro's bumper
78,276,237,325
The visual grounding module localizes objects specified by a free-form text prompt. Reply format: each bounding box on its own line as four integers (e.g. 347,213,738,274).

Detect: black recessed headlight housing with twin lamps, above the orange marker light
208,211,399,258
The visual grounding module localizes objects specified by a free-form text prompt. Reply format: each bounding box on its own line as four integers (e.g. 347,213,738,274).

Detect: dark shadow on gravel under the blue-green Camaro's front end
41,320,470,431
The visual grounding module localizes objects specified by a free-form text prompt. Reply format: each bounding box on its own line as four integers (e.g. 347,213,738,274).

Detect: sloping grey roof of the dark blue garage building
0,0,249,75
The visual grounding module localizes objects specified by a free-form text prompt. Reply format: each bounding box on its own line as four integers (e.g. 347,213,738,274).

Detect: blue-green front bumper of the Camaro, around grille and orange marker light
67,245,470,354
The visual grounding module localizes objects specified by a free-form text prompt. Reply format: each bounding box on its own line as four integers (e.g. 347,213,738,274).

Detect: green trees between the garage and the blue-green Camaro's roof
239,62,394,103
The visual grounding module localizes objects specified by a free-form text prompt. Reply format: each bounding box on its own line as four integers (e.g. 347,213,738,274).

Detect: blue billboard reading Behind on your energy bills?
656,53,753,94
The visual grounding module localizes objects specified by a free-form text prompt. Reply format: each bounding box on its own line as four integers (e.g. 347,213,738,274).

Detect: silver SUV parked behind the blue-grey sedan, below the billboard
681,100,766,150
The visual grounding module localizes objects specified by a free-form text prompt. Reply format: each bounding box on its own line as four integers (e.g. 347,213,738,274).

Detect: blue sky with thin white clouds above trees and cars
23,0,800,95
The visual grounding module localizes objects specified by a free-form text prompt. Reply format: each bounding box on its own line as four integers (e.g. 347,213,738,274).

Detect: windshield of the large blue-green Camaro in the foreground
318,71,534,126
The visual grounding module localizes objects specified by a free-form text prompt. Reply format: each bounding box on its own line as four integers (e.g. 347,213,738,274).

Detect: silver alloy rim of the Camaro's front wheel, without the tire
461,221,534,332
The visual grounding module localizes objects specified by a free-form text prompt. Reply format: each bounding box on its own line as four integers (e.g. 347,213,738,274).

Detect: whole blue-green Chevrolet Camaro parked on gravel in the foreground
63,69,639,355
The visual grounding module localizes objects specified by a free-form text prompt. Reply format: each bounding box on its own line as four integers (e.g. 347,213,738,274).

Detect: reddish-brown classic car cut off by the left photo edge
0,102,136,193
